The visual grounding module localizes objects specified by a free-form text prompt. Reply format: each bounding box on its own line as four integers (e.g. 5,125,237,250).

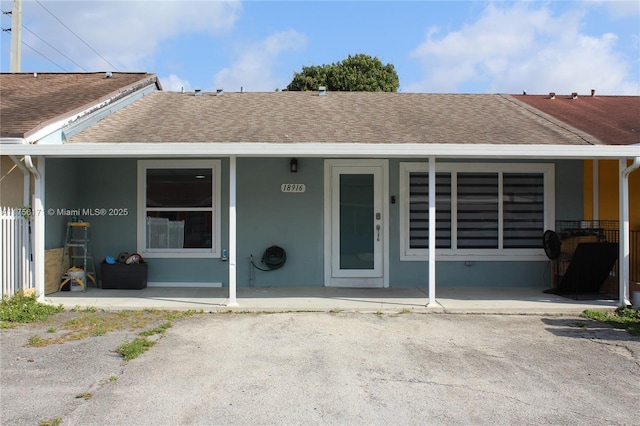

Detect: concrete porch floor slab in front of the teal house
45,287,617,315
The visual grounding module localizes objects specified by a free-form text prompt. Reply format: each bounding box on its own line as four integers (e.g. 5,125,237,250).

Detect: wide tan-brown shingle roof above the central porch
70,91,598,145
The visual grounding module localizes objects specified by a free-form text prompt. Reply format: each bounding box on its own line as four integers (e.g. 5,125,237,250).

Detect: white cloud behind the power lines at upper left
20,0,241,71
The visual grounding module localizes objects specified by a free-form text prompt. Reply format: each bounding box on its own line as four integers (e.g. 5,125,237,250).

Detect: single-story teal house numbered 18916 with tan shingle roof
2,73,640,304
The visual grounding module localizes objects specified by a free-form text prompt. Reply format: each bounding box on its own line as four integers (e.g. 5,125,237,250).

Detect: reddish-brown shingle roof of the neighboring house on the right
515,95,640,145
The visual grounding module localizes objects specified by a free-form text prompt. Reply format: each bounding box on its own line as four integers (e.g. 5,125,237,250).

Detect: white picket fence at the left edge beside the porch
0,207,33,297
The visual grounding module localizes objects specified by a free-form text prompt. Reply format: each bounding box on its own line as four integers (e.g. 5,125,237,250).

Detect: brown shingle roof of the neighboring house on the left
0,73,159,138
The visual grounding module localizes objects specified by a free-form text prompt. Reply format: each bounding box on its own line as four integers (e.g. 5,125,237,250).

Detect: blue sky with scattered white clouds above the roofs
0,0,640,95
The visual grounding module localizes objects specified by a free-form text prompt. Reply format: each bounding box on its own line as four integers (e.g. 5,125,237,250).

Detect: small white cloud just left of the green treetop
213,30,307,92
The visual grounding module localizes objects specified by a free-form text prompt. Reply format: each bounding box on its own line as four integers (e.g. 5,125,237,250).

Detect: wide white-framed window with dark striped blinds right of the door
400,163,554,260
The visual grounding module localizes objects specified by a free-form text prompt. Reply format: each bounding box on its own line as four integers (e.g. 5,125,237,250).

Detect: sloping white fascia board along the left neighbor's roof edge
24,75,157,143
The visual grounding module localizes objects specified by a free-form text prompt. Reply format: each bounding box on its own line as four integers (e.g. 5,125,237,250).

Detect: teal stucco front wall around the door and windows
45,158,583,288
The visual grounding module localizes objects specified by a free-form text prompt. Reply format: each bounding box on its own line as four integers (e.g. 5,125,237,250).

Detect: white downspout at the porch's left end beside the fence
24,155,44,302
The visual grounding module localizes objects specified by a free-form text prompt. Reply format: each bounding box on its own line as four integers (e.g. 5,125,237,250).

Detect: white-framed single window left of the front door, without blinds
138,160,220,258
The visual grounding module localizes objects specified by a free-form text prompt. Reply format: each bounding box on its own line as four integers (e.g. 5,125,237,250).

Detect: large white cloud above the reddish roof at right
404,3,639,94
